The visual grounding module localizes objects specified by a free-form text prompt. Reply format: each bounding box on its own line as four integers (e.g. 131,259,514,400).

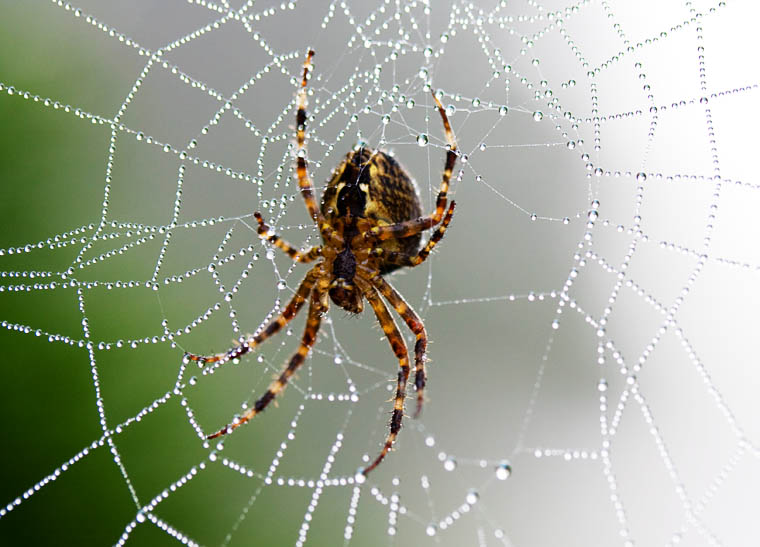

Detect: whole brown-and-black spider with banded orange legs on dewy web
186,50,457,476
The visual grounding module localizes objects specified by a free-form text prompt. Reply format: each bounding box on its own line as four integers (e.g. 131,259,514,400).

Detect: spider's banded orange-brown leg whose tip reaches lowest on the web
354,276,409,475
